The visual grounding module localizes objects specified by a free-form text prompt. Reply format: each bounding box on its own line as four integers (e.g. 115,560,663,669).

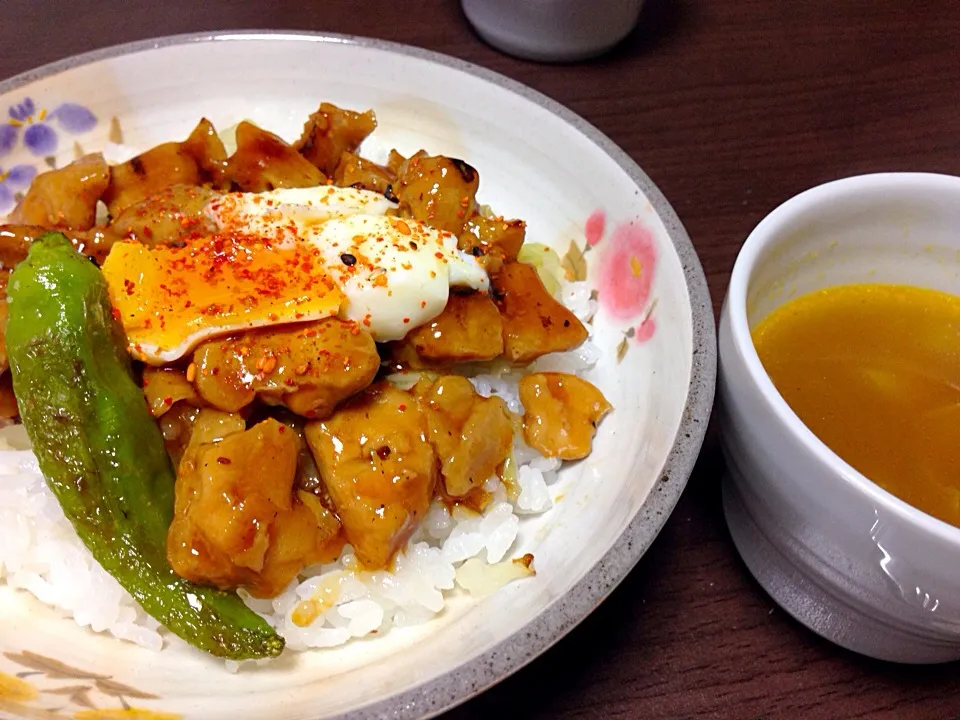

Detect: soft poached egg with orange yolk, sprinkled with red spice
103,186,489,365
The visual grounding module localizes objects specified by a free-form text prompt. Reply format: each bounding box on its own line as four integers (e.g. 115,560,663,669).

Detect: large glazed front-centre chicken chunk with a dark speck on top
306,383,437,570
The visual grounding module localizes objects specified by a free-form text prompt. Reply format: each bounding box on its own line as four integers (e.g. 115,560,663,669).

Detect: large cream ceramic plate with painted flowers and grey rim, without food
0,32,716,720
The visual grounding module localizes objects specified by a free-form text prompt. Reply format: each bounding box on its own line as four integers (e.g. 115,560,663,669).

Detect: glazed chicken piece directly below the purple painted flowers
9,153,110,230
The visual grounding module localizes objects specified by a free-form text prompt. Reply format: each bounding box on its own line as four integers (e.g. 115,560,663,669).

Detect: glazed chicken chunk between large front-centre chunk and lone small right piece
414,375,514,498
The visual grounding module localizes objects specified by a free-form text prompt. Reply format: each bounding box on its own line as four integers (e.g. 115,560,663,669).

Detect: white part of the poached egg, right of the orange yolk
205,186,489,342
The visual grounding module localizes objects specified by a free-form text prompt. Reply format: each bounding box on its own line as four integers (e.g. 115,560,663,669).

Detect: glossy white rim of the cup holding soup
726,172,960,546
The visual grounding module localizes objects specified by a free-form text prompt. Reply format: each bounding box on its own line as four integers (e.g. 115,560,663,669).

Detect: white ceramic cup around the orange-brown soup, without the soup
719,173,960,663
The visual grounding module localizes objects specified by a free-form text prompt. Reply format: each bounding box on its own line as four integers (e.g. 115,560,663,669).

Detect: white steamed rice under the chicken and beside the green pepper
0,283,598,670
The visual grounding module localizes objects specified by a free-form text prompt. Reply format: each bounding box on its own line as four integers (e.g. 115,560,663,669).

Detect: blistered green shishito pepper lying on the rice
7,233,284,660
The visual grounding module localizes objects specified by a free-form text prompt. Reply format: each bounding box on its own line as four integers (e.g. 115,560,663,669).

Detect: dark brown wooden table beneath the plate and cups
7,0,960,720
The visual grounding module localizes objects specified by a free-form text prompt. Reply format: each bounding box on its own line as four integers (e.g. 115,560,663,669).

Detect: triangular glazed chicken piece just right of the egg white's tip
490,262,588,364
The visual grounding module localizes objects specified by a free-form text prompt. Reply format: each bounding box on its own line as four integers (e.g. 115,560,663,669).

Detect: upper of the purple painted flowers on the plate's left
0,98,97,157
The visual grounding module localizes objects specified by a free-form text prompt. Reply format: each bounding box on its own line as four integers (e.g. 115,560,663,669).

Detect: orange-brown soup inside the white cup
753,284,960,526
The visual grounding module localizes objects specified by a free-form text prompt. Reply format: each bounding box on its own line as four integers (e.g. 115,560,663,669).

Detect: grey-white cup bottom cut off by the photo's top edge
462,0,643,62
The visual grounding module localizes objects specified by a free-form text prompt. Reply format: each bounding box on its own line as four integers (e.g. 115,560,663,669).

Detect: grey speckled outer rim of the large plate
0,29,717,720
